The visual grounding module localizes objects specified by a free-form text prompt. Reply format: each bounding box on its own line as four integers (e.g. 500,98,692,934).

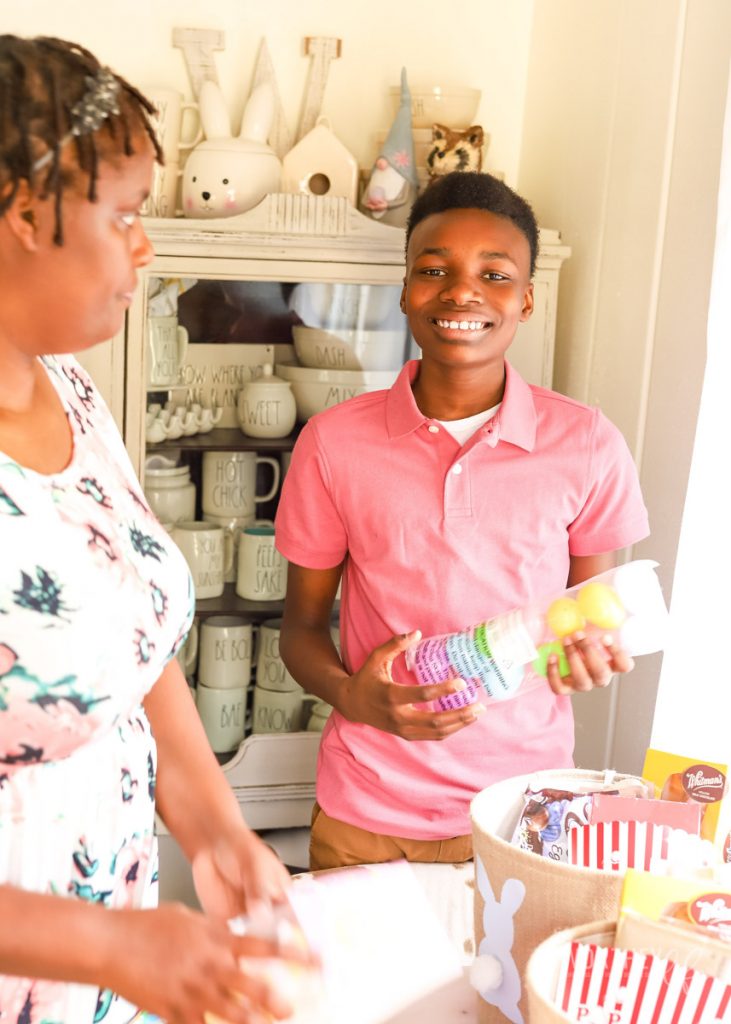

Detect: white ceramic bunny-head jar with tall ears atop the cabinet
182,81,282,217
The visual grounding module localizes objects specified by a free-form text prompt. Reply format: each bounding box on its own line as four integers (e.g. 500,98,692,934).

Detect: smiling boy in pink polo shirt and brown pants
276,172,648,868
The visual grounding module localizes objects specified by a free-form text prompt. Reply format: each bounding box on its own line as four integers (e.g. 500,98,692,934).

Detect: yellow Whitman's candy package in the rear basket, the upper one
642,748,731,863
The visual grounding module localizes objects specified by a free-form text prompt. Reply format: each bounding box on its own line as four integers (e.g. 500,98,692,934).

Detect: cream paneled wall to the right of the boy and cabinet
519,0,731,771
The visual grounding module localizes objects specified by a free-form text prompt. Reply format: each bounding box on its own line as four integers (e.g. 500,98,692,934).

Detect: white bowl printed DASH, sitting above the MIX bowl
292,326,406,370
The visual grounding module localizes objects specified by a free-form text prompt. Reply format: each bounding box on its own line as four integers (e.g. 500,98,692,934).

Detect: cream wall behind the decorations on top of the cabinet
2,0,532,180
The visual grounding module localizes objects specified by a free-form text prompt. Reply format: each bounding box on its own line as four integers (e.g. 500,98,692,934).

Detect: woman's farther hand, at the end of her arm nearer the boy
191,821,290,921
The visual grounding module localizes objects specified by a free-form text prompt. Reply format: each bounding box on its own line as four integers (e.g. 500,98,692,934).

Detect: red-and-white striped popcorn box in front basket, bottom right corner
556,942,731,1024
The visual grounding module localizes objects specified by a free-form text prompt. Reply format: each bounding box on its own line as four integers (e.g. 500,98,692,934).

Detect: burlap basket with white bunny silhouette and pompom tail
471,769,641,1024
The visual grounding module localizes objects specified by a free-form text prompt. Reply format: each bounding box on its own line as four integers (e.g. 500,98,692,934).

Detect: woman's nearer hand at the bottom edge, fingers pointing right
102,903,307,1024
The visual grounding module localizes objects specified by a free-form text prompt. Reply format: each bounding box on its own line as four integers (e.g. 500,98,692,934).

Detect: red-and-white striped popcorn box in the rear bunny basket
568,821,672,871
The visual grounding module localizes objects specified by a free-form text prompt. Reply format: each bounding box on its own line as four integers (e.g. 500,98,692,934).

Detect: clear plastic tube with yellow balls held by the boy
405,559,668,711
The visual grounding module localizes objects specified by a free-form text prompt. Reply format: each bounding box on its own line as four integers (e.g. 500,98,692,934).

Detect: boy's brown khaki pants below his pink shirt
309,803,472,871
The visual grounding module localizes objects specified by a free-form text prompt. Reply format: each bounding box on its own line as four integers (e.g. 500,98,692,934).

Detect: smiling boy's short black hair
406,171,539,278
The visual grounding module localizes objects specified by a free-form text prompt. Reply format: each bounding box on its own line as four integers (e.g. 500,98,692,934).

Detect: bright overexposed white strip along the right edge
652,64,731,763
